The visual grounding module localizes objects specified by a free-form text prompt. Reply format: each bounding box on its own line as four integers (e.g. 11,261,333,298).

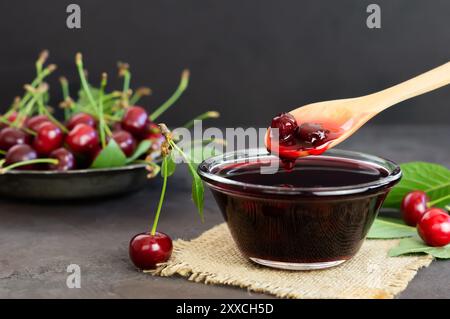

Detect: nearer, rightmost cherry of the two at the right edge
417,208,450,247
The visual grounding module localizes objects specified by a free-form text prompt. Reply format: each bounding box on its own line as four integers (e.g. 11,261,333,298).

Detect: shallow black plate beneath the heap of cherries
0,164,154,200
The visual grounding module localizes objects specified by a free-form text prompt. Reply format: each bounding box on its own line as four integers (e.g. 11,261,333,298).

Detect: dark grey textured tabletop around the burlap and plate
0,126,450,298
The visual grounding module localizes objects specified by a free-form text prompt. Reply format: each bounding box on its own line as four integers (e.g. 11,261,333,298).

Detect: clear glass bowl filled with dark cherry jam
198,149,401,270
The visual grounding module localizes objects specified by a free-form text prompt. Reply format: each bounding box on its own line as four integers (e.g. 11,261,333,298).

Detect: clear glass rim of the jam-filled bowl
197,148,402,196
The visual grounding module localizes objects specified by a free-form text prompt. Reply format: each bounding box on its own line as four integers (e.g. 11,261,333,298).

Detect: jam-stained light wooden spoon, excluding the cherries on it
266,62,450,159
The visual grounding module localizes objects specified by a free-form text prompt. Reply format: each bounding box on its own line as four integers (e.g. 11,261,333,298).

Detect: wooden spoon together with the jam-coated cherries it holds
265,62,450,161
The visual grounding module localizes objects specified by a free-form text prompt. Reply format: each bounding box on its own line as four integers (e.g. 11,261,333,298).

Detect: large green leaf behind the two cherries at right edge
384,162,450,209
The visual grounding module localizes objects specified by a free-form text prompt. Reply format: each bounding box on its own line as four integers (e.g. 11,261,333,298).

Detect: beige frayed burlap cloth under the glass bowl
153,224,432,298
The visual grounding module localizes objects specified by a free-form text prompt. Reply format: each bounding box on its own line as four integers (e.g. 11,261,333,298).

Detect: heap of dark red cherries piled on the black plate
0,106,164,171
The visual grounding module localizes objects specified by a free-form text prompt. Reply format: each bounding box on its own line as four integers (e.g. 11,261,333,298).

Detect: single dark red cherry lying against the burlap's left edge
129,232,173,270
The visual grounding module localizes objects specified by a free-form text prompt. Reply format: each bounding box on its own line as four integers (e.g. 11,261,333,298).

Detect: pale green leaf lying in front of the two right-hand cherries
389,237,450,259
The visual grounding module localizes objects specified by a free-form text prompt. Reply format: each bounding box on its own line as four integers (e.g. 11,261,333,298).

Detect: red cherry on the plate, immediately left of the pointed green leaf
66,123,99,154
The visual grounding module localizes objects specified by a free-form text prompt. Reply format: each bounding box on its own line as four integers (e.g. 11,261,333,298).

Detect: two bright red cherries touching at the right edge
400,191,450,247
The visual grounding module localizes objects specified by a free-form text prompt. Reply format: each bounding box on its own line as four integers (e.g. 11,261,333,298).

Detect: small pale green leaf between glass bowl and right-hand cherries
367,218,417,239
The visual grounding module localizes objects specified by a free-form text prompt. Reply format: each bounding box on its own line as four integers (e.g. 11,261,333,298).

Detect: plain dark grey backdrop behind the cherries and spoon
0,0,450,126
